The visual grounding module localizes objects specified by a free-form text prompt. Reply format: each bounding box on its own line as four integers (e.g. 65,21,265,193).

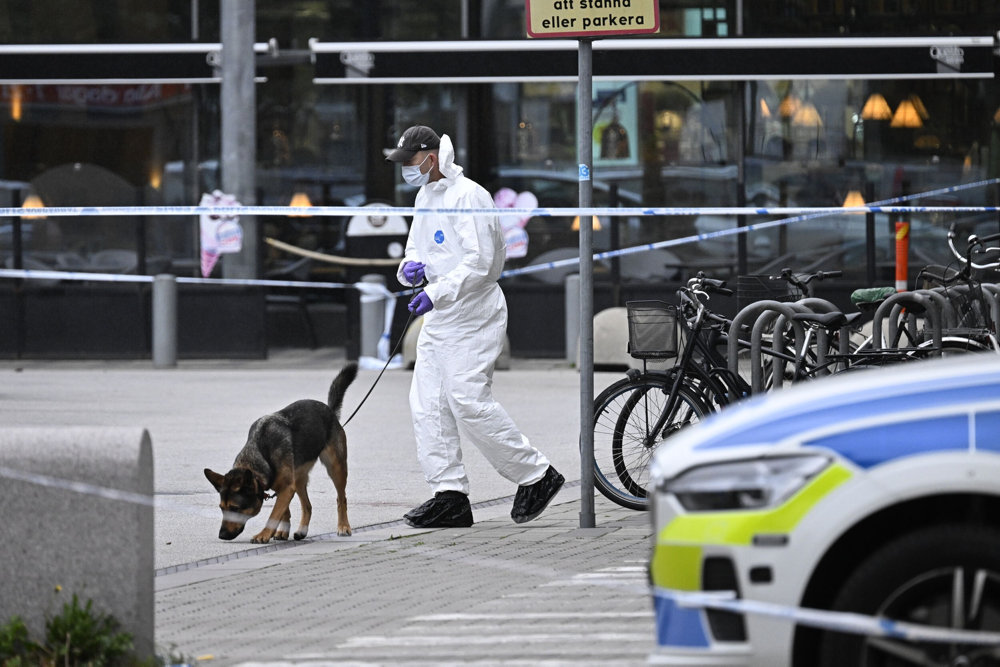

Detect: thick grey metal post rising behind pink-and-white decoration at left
219,0,259,279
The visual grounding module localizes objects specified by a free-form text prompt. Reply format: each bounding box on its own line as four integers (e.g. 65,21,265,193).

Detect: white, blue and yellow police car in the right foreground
650,355,1000,667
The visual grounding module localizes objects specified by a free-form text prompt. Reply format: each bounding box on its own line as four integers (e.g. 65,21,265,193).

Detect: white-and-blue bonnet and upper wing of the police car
656,354,1000,476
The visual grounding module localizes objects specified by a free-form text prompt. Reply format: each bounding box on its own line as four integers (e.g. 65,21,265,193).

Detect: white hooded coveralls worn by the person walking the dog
397,135,549,494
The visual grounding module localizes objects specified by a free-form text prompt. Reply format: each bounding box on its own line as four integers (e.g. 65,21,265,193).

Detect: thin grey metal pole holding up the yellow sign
576,39,594,528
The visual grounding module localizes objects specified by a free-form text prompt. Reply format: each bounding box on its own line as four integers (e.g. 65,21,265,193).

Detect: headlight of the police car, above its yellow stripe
660,454,831,512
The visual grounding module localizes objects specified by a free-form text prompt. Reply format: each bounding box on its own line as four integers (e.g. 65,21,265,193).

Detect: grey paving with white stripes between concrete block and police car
156,490,654,666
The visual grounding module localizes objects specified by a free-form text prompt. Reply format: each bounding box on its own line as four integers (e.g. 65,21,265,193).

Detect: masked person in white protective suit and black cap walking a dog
385,125,564,528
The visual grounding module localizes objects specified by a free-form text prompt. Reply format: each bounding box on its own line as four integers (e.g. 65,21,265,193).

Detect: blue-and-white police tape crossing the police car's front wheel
652,586,1000,646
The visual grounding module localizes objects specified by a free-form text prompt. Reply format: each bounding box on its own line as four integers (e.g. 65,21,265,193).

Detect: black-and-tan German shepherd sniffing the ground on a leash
205,363,358,543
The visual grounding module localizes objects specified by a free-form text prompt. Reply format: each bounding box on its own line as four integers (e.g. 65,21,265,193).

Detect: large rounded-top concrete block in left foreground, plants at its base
0,427,154,658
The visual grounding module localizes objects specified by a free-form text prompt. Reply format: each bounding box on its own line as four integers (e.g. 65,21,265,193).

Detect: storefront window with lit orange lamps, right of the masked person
482,72,996,279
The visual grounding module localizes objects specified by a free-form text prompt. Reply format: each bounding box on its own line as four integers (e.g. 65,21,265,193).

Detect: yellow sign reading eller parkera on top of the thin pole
526,0,660,37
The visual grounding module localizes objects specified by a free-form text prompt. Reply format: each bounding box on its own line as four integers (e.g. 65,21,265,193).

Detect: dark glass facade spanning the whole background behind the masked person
0,0,1000,290
